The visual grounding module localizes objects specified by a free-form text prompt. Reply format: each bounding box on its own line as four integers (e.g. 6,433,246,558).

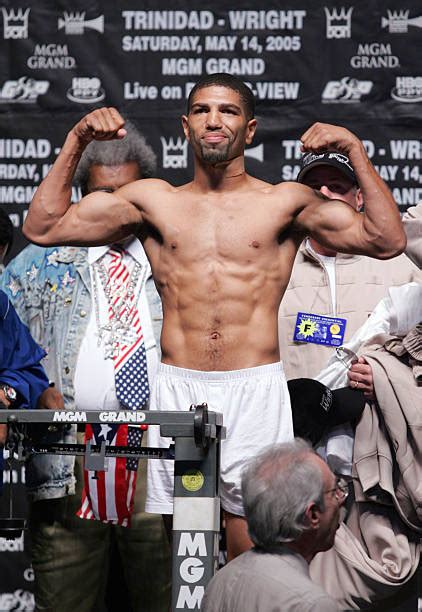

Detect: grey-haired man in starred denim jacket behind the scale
1,127,170,612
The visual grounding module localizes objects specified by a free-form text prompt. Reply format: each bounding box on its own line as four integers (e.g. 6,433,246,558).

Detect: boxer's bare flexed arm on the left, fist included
23,108,142,246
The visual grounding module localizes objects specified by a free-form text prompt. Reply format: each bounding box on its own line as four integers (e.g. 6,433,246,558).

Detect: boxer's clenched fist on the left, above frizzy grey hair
73,107,126,144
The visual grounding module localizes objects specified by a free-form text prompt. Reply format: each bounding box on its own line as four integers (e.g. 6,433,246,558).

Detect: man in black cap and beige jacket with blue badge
279,150,422,399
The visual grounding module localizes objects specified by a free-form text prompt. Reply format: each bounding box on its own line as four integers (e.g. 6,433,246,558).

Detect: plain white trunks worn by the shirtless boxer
145,363,293,516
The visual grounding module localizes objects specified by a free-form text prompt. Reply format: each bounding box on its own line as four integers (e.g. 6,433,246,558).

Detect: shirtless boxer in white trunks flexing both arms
24,74,406,558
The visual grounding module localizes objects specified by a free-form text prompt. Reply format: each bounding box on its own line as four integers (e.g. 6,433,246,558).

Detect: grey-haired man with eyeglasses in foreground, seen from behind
201,438,348,612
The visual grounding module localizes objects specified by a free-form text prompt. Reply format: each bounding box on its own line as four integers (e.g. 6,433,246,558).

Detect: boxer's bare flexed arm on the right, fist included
297,123,406,259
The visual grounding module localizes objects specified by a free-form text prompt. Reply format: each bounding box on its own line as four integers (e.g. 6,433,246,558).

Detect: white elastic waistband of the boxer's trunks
158,361,284,381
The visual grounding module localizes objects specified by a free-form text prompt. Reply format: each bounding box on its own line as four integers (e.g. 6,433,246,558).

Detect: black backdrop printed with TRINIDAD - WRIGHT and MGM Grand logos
0,0,422,609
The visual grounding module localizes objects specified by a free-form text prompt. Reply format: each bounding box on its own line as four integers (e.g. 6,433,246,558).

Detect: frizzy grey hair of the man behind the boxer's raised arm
75,121,157,195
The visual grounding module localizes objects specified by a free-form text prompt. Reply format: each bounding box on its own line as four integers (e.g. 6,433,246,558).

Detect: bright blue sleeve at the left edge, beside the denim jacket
0,291,48,408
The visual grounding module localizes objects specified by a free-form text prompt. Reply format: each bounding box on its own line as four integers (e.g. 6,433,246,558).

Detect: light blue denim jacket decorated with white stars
0,245,162,500
